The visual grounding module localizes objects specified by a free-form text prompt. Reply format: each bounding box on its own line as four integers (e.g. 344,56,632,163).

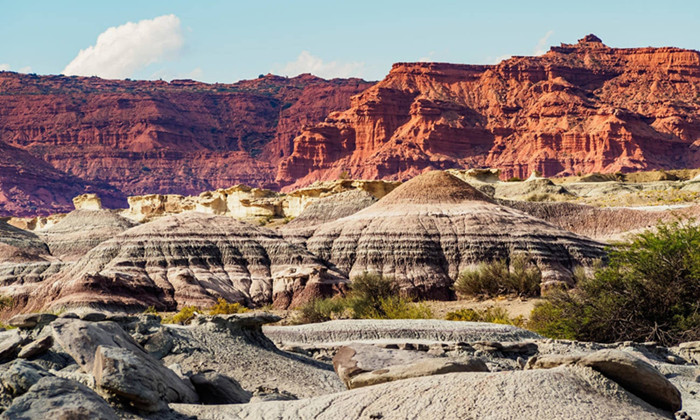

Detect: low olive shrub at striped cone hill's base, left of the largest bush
454,254,542,297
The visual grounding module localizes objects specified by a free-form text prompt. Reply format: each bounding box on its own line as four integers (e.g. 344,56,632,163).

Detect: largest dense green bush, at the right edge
529,221,700,345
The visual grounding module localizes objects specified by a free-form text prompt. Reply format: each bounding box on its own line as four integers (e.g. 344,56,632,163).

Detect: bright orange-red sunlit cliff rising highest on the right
277,35,700,189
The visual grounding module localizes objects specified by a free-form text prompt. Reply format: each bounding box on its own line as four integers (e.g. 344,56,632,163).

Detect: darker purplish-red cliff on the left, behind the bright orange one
0,72,370,215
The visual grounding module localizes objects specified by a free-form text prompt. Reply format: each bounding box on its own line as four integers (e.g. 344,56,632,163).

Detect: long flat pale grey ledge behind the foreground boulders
263,319,542,346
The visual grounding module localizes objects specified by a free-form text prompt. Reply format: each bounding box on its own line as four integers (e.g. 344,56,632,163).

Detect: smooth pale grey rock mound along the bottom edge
171,367,670,420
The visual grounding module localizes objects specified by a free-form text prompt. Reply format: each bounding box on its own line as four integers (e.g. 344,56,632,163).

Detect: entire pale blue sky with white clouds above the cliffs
0,0,700,82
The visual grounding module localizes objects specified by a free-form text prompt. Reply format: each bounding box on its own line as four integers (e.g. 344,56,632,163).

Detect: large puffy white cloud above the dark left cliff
63,15,184,79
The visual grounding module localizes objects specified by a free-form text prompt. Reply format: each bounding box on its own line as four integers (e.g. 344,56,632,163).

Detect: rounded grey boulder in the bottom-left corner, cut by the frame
3,376,118,420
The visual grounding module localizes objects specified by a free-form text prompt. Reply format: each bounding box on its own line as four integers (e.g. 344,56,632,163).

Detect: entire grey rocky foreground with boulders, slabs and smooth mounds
0,312,700,419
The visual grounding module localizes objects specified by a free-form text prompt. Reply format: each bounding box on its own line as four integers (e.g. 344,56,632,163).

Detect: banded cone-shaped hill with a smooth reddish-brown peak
306,171,603,299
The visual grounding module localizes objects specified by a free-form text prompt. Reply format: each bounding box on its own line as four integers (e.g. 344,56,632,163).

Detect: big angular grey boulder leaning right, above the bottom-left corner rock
92,346,198,412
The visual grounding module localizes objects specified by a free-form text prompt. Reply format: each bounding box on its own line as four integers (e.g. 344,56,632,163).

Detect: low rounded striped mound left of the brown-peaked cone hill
12,212,345,310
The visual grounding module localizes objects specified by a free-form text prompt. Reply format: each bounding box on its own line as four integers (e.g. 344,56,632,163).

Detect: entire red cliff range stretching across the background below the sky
0,36,700,215
